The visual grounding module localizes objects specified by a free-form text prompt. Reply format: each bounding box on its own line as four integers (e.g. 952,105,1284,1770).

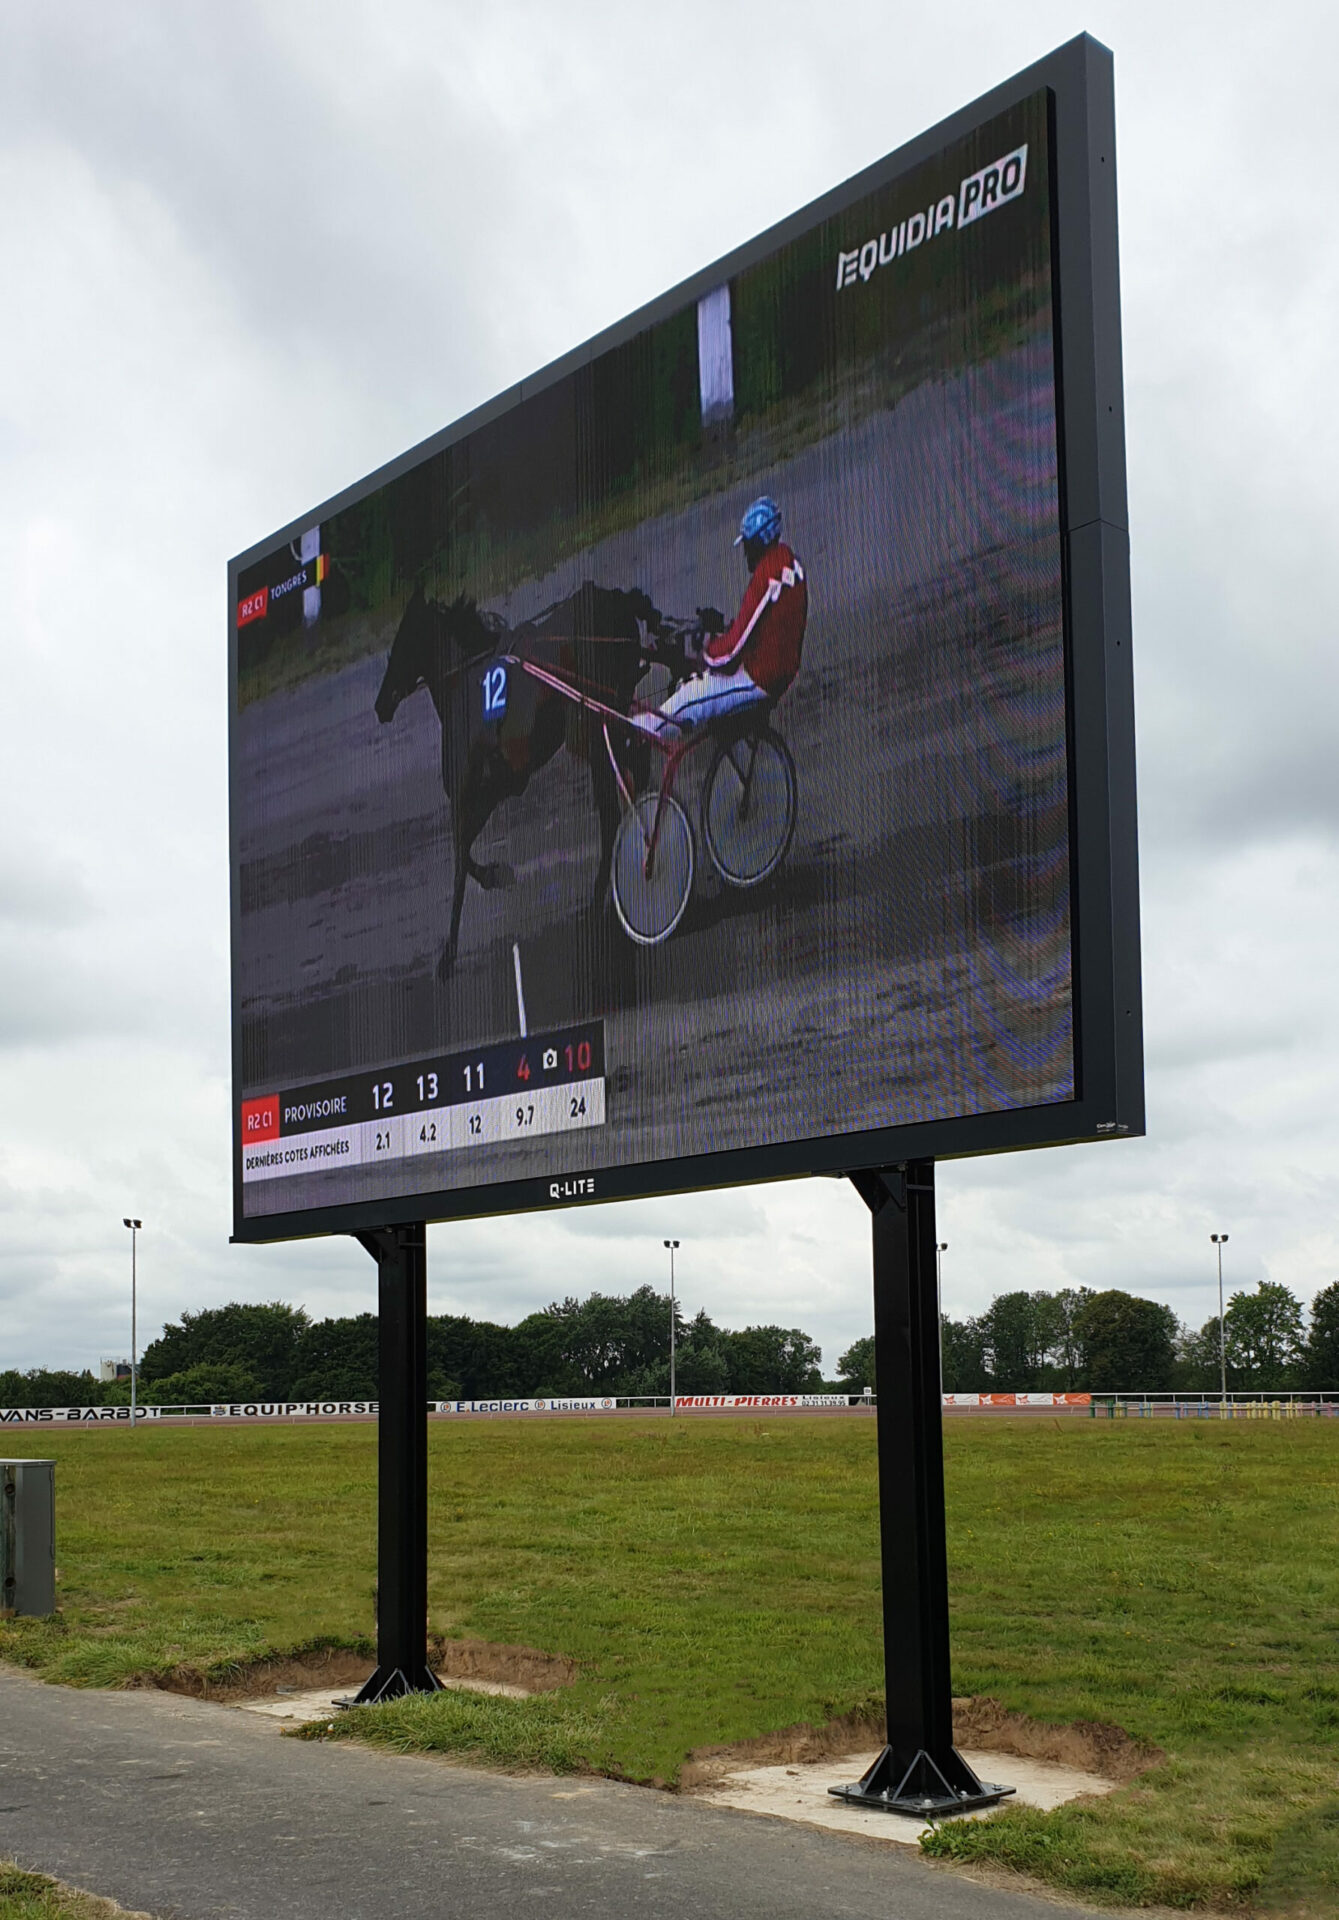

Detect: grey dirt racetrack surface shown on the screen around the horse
236,336,1072,1213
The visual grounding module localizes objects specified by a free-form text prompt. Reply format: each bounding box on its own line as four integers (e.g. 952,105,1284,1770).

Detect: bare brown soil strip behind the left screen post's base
127,1638,576,1705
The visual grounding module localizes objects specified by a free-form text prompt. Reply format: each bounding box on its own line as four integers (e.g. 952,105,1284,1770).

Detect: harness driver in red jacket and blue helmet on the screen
632,493,809,737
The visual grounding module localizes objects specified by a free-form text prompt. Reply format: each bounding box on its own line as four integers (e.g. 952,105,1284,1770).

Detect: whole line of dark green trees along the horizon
0,1281,1339,1407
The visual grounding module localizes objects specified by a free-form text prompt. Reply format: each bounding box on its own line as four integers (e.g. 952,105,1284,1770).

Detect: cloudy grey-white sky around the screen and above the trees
0,0,1339,1367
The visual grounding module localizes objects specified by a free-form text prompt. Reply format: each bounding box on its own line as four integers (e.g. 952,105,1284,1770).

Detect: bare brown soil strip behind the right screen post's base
680,1695,1164,1793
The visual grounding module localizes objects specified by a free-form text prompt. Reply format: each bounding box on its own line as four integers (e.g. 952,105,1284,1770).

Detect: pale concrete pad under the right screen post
697,1753,1116,1847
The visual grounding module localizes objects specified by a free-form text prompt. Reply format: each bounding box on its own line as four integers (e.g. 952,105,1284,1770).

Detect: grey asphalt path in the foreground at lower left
0,1670,1078,1920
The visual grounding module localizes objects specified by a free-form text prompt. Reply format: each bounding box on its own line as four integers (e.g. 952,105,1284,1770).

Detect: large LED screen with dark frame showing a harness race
229,42,1141,1238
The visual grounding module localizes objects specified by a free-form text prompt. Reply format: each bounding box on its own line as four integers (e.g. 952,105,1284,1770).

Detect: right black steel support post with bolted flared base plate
828,1160,1014,1820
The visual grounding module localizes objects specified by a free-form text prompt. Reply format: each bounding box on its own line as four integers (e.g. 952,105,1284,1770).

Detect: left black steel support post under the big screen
353,1221,442,1707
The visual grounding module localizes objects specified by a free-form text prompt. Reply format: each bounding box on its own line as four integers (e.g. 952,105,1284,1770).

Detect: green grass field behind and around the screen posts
0,1417,1339,1914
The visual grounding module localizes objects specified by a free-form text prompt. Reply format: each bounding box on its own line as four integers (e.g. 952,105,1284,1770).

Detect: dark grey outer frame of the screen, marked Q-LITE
229,35,1145,1244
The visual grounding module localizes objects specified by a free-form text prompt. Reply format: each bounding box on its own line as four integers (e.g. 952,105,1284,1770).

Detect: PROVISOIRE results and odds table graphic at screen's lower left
242,1021,605,1183
